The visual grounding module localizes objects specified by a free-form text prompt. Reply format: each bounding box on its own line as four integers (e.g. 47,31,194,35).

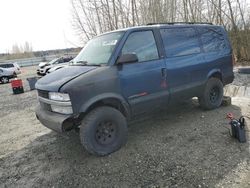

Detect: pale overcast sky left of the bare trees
0,0,79,53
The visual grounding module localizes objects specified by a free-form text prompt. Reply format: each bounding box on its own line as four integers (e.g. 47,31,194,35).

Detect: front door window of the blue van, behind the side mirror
122,31,159,62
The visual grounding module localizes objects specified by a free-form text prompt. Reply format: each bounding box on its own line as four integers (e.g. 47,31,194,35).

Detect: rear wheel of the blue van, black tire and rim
198,78,223,110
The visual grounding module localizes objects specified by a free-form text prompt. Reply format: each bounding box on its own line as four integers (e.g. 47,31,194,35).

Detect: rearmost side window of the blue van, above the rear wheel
198,28,227,52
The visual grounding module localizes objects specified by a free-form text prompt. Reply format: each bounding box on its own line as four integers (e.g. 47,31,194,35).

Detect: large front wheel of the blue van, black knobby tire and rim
80,106,128,156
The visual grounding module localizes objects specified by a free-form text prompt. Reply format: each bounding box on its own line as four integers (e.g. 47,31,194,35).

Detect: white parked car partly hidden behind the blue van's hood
37,57,73,76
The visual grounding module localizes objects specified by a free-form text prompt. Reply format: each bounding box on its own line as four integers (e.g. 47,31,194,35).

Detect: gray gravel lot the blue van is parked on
0,67,250,187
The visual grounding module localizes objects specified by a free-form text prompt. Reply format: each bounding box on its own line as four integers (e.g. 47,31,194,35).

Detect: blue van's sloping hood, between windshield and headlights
35,66,97,92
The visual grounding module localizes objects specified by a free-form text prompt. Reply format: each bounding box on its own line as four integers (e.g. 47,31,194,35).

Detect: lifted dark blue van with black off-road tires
36,23,234,155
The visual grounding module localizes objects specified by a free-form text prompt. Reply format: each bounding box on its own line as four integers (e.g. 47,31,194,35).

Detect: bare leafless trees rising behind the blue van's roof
71,0,250,61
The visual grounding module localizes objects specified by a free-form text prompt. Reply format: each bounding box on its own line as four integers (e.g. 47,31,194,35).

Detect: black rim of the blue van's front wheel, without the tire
95,121,117,145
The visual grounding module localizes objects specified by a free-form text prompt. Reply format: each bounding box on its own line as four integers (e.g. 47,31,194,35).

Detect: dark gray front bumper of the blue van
36,106,73,133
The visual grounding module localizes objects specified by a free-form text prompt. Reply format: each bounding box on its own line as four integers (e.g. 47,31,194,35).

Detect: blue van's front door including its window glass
119,30,168,115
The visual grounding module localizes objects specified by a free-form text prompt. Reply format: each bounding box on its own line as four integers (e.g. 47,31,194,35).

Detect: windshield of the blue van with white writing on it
73,32,124,65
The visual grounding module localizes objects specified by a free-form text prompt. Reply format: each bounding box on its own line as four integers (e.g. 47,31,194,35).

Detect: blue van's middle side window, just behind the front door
161,28,201,57
